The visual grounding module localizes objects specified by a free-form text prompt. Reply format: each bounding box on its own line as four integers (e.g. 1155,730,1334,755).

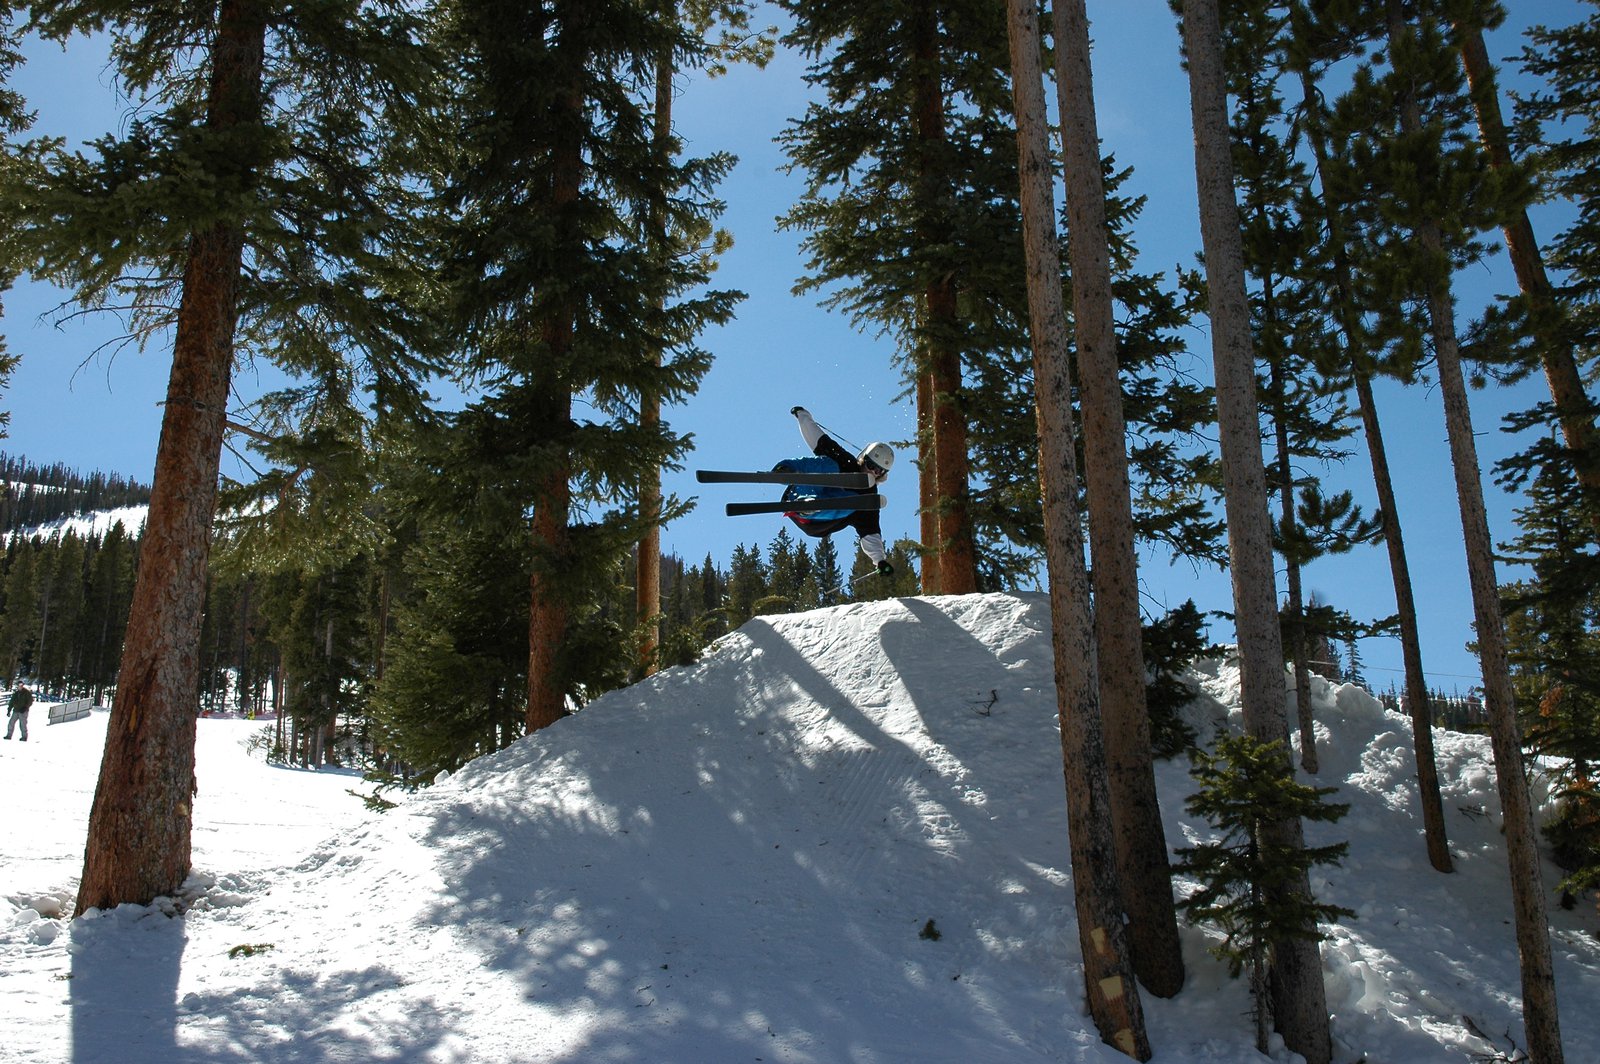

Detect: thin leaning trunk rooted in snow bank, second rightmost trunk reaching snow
1296,49,1453,872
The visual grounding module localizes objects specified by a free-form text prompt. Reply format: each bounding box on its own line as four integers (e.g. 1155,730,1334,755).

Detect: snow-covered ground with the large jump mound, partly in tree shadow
0,595,1600,1064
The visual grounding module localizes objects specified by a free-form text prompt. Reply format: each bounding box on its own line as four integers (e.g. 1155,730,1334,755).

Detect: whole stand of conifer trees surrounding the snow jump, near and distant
0,0,1600,1064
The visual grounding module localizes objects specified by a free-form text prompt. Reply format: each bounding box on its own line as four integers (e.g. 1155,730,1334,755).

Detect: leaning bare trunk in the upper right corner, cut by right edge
1454,18,1600,522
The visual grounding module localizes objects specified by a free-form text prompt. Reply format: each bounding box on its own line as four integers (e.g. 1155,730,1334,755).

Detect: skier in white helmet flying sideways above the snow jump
694,406,894,576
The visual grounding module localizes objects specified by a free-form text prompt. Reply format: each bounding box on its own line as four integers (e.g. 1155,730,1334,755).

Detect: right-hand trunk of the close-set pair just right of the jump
1054,0,1184,997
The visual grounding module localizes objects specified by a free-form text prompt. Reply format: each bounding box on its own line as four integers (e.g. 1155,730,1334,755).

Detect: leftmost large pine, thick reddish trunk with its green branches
19,0,438,912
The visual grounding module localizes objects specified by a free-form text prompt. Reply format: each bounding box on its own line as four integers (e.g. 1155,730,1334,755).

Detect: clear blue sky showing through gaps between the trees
0,0,1590,691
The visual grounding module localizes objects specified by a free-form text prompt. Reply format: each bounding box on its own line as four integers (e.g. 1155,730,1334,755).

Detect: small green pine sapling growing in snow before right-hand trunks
1174,734,1355,1053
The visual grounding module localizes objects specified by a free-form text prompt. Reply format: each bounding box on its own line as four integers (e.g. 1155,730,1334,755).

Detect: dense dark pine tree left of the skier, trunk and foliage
435,0,736,731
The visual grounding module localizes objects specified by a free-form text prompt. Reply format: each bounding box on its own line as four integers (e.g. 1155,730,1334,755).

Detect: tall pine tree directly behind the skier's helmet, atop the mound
779,0,1022,594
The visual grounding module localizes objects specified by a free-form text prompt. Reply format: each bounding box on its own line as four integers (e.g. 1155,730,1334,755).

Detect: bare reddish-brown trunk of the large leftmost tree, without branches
77,0,266,912
